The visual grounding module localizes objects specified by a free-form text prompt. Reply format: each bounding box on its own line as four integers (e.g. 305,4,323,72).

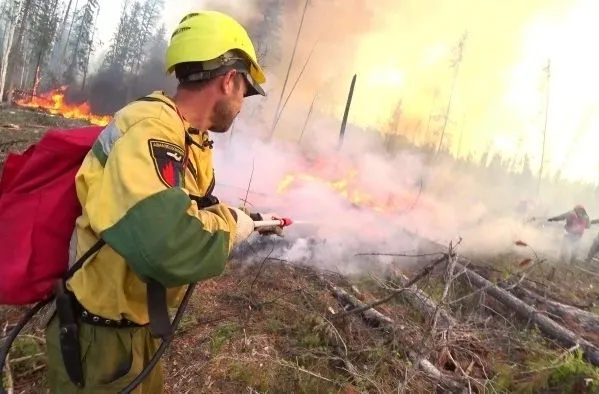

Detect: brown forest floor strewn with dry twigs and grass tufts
0,109,599,394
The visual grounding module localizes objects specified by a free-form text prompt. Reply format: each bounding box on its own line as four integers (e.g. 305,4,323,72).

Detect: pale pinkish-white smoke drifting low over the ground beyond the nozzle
205,106,592,272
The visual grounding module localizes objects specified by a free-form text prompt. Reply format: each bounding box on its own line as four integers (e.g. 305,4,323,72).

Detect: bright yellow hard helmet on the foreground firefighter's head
165,11,266,95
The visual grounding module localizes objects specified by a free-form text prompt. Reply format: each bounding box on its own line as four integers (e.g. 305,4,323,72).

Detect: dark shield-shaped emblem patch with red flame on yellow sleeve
148,139,185,187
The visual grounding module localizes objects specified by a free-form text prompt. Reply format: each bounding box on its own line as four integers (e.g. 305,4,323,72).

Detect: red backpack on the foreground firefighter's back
0,126,103,305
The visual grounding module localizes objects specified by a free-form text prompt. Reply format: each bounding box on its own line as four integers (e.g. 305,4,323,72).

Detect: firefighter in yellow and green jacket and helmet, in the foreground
46,11,281,394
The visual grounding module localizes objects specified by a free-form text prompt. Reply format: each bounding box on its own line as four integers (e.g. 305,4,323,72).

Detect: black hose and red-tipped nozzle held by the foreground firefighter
0,218,293,394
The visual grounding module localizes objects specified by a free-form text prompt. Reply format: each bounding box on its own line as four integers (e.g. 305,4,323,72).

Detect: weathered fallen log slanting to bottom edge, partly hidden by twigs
323,279,468,394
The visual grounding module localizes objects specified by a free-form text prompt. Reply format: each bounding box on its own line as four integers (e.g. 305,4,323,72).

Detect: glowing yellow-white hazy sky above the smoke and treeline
86,0,599,182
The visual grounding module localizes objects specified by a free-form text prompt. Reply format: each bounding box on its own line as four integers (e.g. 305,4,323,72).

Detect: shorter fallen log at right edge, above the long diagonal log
500,284,599,335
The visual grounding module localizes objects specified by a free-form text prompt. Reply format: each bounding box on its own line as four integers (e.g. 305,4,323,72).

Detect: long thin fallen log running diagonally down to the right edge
456,263,599,366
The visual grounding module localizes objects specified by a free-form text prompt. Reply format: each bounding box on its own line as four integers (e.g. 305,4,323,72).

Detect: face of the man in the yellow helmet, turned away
210,72,247,133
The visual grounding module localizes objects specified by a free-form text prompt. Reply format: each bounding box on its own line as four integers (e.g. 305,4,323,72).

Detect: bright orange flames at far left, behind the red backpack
14,86,112,126
